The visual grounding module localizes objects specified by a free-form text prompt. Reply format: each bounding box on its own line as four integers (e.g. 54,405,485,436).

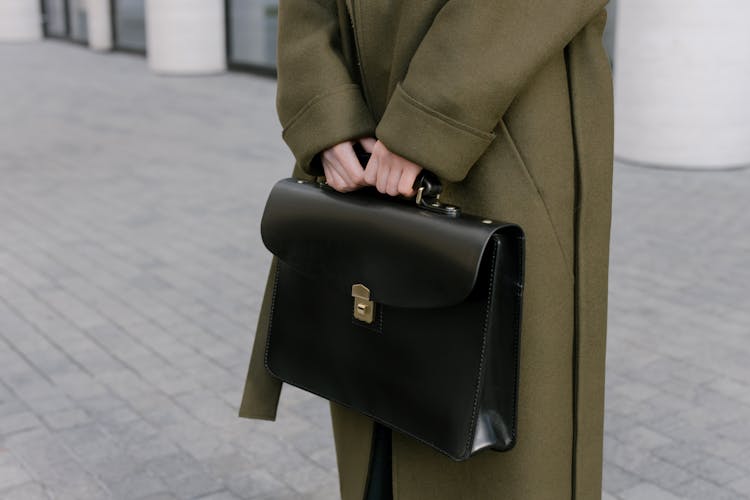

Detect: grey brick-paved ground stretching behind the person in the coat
0,41,750,500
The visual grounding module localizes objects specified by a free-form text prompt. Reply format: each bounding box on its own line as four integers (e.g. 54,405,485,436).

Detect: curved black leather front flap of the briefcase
261,178,512,308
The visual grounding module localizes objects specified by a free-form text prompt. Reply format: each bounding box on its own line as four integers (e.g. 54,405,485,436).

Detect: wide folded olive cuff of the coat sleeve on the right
375,82,495,182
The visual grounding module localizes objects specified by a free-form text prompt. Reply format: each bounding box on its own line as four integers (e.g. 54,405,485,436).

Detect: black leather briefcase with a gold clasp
261,155,524,460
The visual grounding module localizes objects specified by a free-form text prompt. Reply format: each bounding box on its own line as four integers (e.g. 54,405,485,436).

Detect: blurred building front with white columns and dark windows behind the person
0,0,750,168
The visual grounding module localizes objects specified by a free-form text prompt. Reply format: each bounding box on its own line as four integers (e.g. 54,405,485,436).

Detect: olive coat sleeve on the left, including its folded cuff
276,0,375,175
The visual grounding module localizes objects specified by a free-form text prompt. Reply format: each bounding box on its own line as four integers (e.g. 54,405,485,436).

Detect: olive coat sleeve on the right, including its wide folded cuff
376,0,606,182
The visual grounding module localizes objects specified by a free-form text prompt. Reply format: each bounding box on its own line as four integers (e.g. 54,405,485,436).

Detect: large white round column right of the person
614,0,750,168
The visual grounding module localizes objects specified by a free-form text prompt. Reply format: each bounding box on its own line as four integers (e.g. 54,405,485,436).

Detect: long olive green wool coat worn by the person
239,0,613,500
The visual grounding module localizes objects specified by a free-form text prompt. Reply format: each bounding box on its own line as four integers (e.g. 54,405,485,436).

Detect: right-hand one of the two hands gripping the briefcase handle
363,141,422,197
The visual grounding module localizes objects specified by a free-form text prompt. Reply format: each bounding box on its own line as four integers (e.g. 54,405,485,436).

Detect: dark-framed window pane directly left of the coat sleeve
227,0,279,69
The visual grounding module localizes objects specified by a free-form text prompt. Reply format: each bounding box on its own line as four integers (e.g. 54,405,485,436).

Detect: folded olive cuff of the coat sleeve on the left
281,84,375,176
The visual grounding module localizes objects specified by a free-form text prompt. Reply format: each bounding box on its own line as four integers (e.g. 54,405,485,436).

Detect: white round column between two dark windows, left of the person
146,0,226,74
